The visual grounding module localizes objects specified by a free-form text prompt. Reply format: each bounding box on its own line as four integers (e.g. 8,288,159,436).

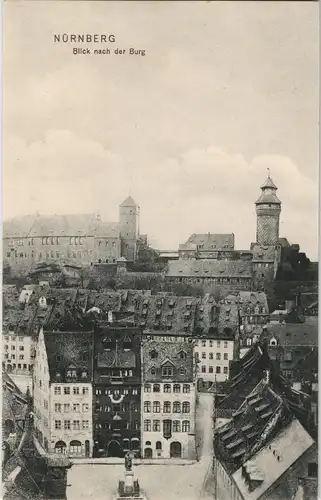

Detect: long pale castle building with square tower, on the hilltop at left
3,197,139,271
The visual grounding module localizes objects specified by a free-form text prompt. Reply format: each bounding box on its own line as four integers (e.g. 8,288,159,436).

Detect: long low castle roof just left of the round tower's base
166,259,252,278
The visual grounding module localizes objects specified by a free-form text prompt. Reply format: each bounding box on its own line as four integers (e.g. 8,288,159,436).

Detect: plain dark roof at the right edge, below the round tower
263,322,318,347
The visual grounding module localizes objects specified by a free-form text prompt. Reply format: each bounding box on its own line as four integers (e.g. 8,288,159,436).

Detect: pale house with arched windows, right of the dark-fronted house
141,338,195,459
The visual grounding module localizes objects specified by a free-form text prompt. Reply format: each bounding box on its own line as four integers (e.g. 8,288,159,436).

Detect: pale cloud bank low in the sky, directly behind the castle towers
4,130,318,258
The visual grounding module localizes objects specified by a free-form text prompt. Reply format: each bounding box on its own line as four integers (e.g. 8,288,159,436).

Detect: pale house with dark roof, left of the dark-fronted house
33,329,93,457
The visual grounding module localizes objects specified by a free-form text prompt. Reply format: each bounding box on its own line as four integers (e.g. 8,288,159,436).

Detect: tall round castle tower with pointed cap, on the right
255,174,281,245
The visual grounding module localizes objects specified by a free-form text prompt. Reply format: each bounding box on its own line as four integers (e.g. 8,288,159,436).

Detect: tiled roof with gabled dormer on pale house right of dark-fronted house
142,340,193,382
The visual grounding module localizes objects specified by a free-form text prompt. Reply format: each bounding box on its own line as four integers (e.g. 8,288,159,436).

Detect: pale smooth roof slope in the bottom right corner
233,419,314,500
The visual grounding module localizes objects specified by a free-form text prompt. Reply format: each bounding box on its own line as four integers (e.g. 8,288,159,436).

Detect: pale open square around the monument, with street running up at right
67,393,213,500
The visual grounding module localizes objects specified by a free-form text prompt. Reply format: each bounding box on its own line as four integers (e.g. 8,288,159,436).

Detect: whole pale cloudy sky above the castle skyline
3,0,318,259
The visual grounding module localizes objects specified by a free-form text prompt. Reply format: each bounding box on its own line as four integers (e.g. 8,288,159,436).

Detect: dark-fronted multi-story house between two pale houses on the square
93,324,141,457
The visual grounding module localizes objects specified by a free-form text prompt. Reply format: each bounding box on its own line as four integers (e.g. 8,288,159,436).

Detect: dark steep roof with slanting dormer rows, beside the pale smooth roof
214,380,291,473
